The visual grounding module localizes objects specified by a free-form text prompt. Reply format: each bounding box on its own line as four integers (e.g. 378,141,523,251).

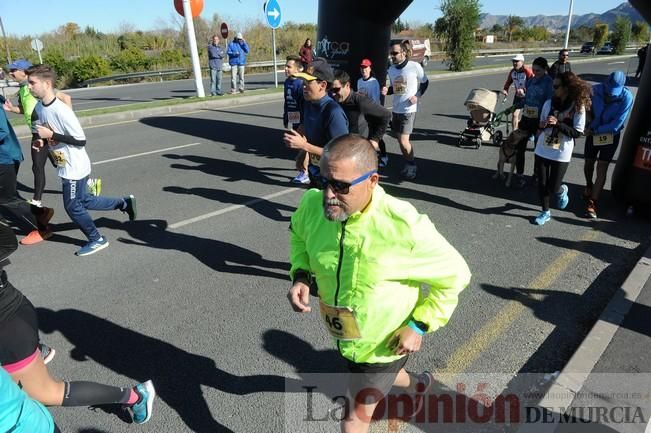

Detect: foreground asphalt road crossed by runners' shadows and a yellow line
7,59,649,433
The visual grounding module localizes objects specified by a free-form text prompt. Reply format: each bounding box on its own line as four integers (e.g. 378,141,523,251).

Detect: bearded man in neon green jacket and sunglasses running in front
288,134,471,432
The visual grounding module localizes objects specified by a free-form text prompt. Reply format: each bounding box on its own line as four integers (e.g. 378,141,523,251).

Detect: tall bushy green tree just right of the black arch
441,0,480,71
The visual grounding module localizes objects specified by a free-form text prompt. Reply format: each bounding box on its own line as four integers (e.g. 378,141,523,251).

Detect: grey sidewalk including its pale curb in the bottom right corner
519,243,651,433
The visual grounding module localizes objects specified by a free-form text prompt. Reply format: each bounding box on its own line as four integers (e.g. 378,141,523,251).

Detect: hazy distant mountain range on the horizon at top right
480,2,646,32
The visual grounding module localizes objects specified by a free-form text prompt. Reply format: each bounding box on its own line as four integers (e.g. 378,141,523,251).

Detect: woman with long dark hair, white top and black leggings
534,72,590,225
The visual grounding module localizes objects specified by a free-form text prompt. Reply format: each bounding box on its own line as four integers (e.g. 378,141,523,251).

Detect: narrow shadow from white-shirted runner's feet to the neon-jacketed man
98,218,289,281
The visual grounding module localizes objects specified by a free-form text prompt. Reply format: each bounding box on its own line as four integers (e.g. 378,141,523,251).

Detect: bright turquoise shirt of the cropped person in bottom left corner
0,367,59,433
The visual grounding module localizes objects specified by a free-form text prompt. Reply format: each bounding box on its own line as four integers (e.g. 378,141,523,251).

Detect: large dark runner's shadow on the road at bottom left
37,308,292,433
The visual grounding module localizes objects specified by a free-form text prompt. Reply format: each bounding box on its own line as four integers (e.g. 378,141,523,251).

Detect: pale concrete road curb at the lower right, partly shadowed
518,243,651,433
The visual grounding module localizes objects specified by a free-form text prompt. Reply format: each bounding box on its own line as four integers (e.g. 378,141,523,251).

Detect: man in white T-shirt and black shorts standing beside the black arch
382,40,429,180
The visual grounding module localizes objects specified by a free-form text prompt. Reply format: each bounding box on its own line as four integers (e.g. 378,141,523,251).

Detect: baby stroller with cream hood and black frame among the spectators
457,89,515,149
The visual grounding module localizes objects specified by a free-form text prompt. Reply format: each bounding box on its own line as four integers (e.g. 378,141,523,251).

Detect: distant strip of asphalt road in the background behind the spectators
12,53,637,111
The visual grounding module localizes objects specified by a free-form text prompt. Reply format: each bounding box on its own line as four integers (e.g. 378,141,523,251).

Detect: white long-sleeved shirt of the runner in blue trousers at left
34,98,90,180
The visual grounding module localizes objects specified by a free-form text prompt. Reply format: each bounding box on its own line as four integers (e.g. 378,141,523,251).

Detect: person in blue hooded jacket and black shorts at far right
583,71,633,219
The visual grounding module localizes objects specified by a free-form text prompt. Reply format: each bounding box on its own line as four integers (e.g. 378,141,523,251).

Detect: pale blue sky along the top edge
0,0,632,36
